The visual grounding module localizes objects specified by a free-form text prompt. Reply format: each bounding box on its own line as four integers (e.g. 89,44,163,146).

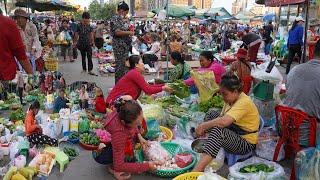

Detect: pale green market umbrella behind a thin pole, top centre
152,4,195,18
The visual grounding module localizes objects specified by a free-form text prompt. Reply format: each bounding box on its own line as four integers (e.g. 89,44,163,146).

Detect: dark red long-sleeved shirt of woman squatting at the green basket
106,112,149,173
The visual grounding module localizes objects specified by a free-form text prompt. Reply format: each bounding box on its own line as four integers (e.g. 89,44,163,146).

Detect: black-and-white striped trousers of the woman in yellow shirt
204,127,256,158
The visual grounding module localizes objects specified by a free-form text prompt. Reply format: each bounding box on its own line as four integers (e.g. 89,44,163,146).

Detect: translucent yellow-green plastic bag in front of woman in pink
191,71,219,102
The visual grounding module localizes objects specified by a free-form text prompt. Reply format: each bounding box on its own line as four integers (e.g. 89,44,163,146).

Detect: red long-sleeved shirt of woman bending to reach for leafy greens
106,69,163,105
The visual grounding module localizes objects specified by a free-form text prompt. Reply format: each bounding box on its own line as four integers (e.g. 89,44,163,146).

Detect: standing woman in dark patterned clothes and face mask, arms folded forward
110,1,134,83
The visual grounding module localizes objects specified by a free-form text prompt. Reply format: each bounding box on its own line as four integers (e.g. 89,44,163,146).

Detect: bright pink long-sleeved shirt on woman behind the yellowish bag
184,62,226,86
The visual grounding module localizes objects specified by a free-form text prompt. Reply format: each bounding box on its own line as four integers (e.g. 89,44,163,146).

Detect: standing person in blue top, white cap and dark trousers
286,17,304,74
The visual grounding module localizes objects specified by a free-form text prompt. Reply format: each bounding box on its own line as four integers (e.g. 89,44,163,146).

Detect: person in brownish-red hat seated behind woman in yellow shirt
230,48,252,94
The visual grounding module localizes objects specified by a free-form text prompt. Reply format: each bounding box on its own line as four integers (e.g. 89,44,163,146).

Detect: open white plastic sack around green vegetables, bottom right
228,157,285,180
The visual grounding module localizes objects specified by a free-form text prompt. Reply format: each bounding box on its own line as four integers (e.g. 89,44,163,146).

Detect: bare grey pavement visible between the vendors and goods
48,54,292,180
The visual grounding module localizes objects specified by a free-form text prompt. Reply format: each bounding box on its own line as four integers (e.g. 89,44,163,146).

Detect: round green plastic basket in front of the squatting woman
155,142,197,178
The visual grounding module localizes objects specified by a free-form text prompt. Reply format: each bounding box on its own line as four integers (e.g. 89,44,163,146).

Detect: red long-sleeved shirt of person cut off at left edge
0,15,27,81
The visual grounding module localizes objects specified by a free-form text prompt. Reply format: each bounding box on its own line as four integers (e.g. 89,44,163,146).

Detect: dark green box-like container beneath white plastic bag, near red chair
253,81,274,101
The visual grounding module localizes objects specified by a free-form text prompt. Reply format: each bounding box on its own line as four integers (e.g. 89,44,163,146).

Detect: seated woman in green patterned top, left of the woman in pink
165,52,191,82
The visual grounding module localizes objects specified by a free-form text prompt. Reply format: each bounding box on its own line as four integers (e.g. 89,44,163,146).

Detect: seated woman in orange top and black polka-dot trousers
24,100,58,146
